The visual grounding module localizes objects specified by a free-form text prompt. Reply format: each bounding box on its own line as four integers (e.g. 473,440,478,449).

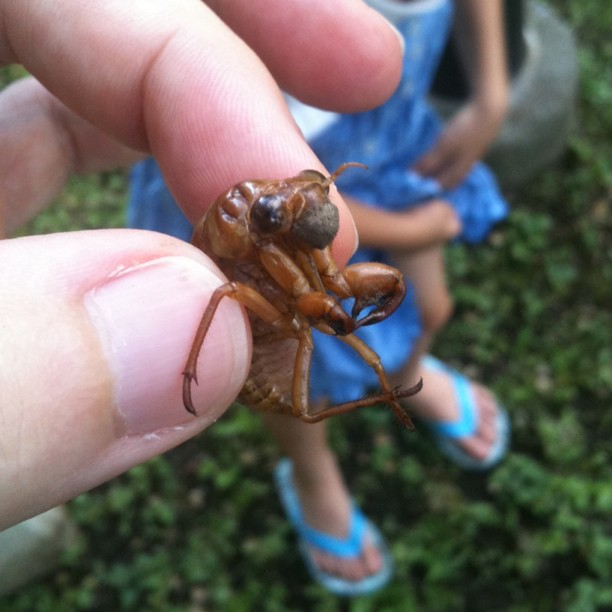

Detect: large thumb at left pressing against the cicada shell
0,230,250,529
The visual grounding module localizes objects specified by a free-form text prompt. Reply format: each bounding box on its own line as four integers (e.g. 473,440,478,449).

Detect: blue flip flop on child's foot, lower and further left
274,459,393,597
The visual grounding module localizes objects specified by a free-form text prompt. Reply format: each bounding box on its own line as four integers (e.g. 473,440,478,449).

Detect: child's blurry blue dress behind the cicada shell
128,0,507,403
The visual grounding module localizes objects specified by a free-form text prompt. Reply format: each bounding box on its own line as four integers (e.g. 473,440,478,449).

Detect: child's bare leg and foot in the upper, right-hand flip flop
394,247,497,459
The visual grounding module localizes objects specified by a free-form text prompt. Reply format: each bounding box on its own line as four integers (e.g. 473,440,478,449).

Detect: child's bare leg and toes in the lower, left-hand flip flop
262,414,382,581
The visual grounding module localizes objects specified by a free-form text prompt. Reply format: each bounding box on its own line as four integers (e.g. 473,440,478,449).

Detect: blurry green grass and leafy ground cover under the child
0,0,612,612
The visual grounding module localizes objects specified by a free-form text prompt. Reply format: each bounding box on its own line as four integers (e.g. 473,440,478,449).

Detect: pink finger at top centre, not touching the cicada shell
208,0,403,112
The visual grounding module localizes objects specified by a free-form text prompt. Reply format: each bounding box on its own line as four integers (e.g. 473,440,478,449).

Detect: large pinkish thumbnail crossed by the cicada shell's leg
85,256,250,435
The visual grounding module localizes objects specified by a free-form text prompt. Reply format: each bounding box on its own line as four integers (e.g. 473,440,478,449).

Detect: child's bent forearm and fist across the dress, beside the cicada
342,193,461,251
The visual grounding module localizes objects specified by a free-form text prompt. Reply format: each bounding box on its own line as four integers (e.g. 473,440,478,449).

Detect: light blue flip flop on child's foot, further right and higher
422,355,510,470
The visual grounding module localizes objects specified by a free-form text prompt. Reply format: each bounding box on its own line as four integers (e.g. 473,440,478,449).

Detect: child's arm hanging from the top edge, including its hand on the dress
415,0,508,188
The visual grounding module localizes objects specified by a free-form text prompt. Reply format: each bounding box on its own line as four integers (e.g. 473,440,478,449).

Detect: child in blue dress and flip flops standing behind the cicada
129,0,508,595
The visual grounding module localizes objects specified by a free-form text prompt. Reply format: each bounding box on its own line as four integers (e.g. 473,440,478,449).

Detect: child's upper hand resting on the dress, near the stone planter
413,101,505,189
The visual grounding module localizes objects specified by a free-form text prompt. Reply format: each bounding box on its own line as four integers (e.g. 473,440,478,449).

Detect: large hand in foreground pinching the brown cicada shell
0,0,400,528
